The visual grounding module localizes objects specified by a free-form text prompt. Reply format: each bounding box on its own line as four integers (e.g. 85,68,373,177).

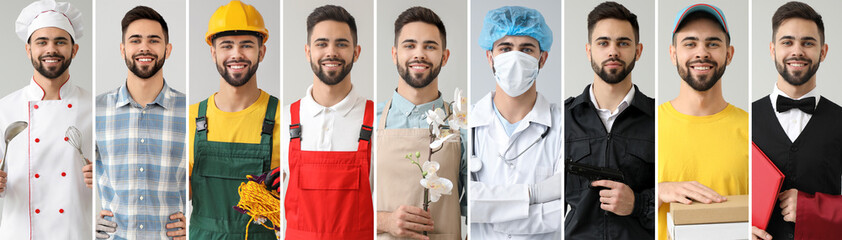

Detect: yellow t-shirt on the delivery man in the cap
658,102,749,239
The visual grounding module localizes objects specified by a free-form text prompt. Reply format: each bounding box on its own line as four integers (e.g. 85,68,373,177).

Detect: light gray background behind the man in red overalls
283,0,372,105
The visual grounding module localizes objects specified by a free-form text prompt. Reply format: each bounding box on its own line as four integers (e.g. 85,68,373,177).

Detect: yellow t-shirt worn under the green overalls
187,90,281,176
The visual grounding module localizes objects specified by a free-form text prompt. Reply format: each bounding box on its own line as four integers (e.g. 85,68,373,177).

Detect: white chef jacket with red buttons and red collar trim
0,79,92,239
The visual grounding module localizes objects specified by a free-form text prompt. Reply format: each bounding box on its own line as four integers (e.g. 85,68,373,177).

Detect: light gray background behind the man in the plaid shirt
95,0,187,94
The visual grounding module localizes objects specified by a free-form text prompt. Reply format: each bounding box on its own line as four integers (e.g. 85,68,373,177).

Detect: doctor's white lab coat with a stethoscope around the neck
468,92,562,240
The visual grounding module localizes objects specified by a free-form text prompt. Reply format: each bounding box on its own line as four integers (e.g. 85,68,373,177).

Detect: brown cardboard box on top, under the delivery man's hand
670,195,748,225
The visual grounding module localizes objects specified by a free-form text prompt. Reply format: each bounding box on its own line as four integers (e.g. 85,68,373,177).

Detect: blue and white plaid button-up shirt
96,83,187,239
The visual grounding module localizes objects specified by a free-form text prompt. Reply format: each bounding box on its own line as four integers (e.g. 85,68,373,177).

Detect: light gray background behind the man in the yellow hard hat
189,0,281,104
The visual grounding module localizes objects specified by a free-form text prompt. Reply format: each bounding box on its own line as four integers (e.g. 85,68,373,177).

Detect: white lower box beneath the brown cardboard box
667,213,751,240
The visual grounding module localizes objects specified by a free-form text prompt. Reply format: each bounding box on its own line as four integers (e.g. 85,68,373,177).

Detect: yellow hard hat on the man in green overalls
205,0,269,45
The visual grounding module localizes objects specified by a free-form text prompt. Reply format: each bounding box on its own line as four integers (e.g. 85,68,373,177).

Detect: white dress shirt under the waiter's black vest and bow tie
769,83,821,142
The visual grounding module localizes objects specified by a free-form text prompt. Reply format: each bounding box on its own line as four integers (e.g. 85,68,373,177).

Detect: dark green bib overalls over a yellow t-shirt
190,96,278,240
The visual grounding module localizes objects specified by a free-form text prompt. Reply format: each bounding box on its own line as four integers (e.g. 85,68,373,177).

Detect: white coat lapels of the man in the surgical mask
468,91,555,131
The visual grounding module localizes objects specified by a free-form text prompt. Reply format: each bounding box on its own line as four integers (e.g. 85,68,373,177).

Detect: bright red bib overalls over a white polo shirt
284,100,374,240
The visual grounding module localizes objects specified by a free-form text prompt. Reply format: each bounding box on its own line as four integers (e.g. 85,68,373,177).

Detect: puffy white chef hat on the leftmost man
15,0,83,42
